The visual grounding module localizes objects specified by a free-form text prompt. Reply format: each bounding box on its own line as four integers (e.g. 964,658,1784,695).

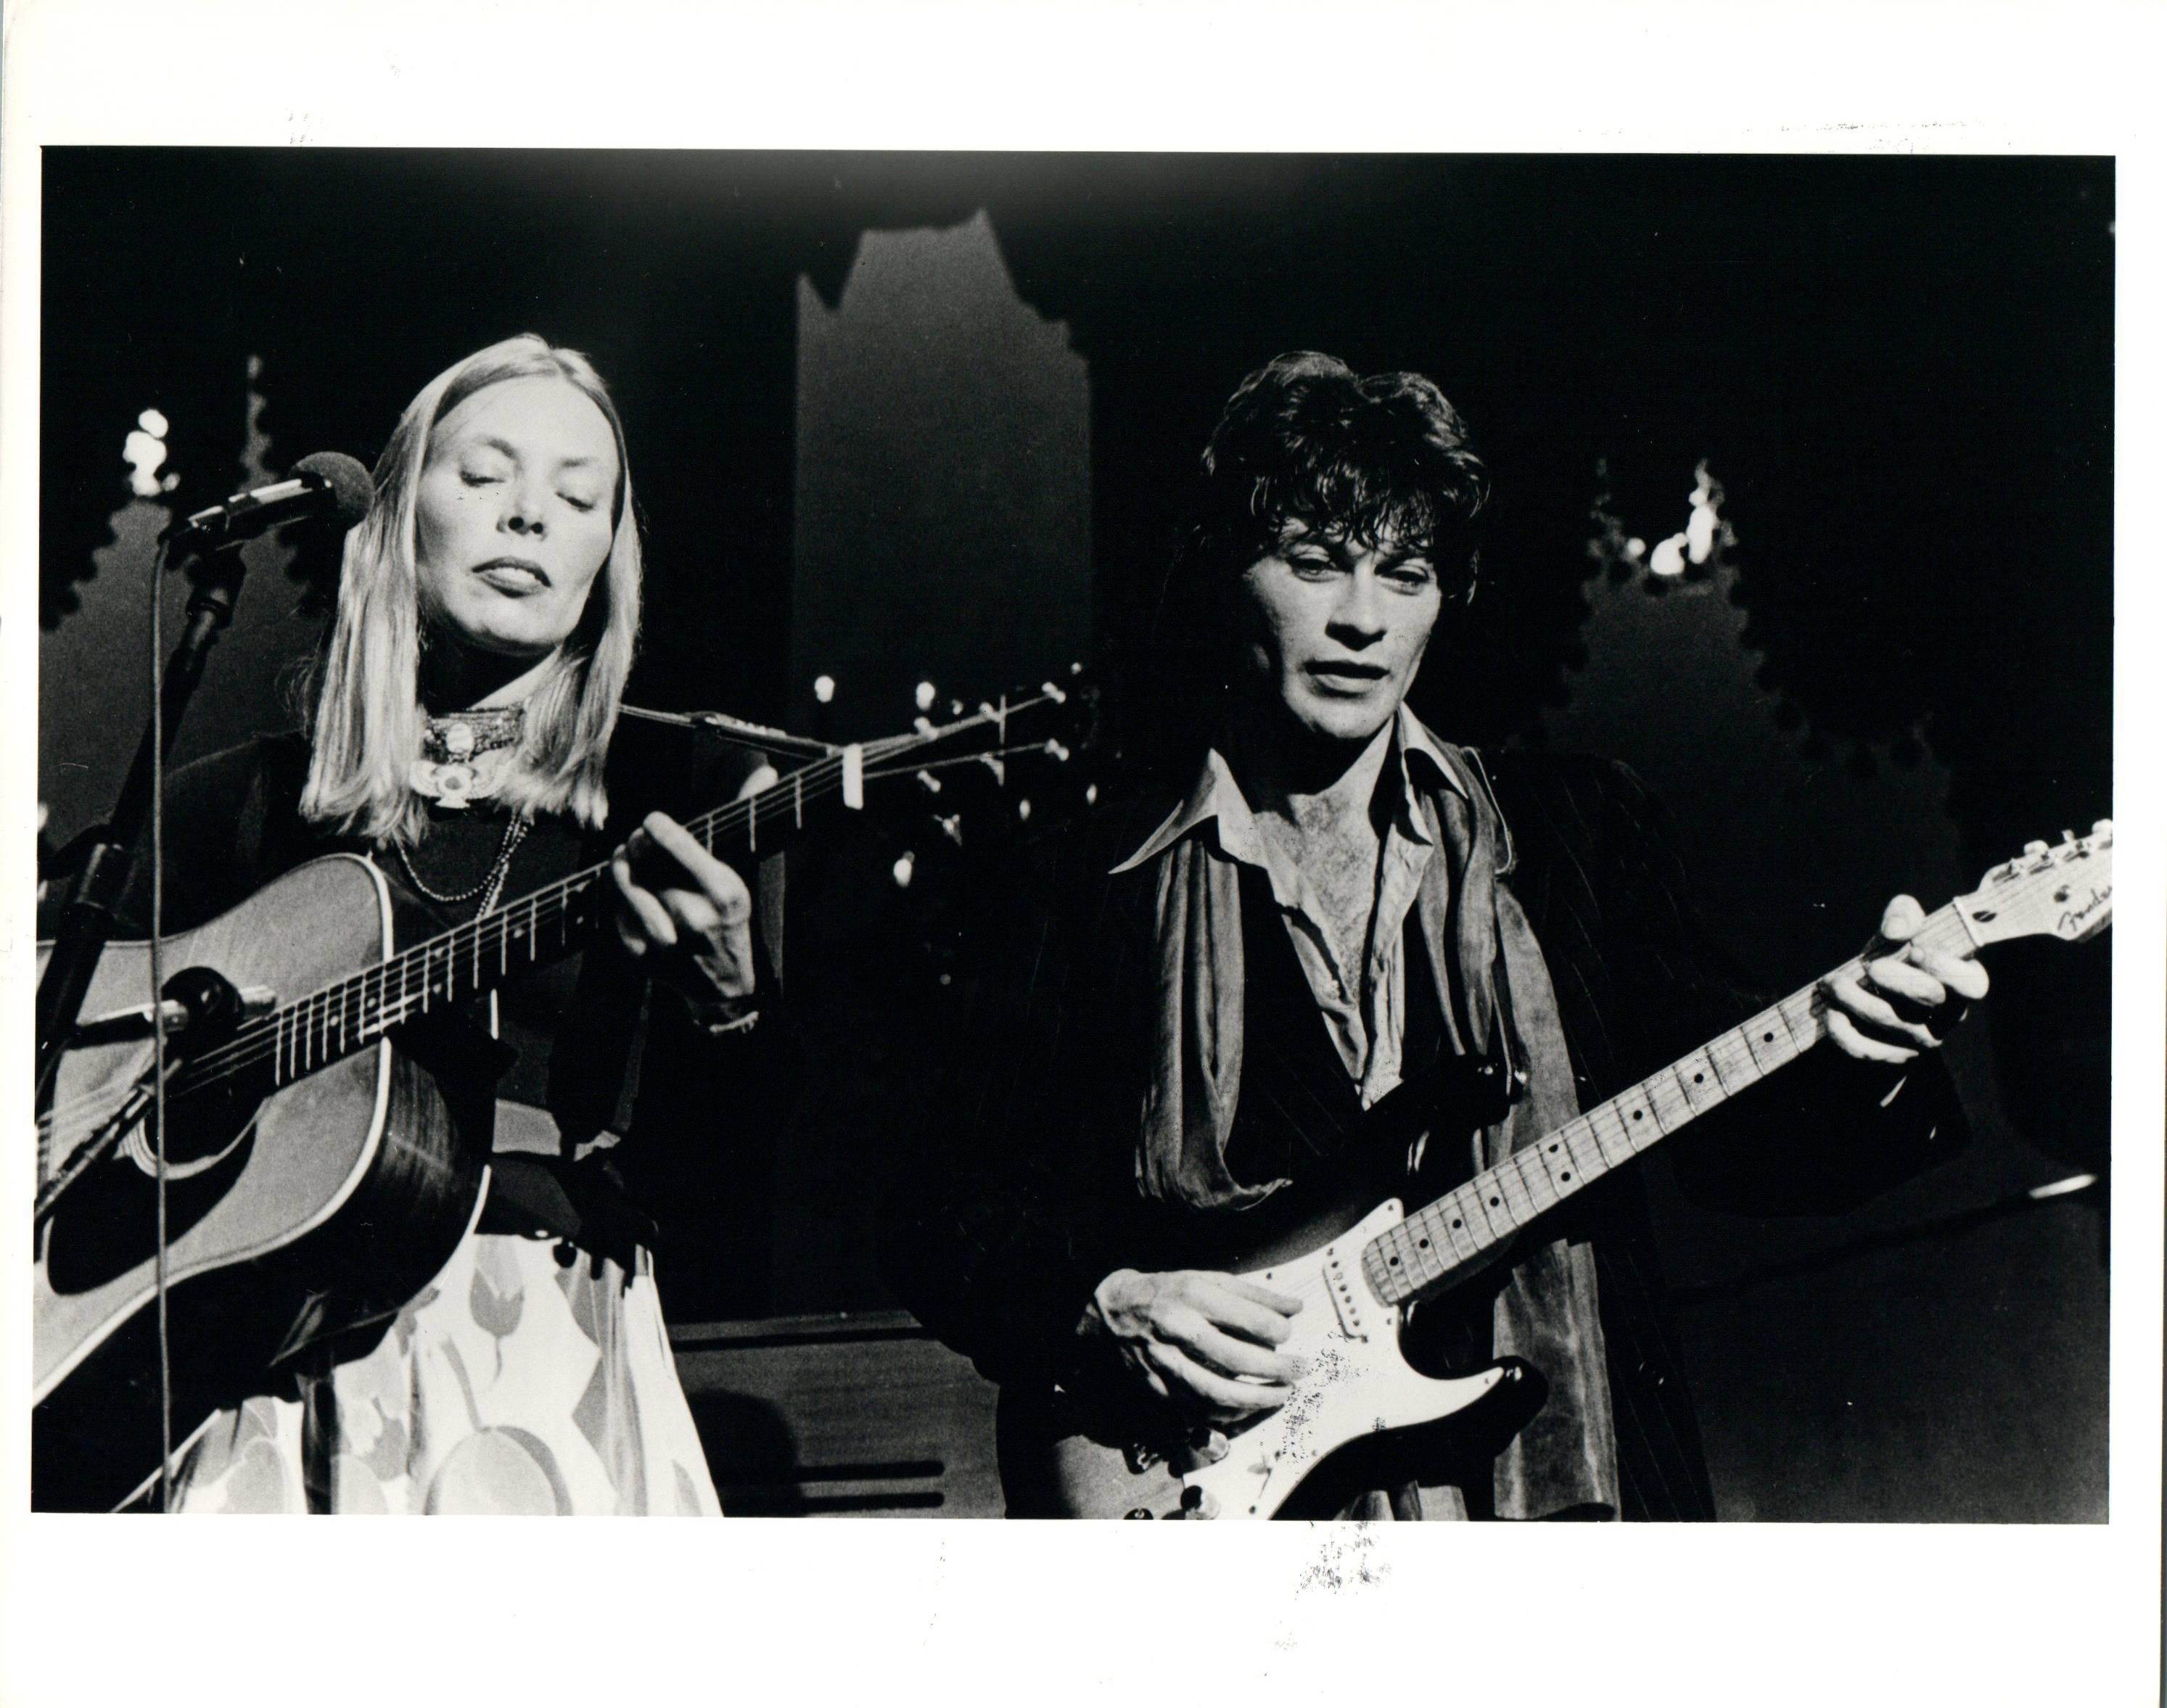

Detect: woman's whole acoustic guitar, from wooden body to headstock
33,680,1092,1511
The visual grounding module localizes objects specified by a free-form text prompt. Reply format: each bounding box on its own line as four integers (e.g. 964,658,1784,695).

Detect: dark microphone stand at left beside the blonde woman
37,540,247,1110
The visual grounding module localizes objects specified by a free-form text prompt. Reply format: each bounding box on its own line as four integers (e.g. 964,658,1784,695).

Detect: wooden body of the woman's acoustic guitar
30,854,488,1511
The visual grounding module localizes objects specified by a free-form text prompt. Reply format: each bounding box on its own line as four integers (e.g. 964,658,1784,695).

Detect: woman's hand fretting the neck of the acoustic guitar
609,765,776,1023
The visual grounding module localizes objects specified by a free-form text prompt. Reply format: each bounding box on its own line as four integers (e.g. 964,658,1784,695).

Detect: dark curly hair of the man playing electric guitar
1188,349,1489,601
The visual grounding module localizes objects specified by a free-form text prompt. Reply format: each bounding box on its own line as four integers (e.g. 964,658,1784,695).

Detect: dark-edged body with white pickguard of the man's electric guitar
999,1199,1530,1517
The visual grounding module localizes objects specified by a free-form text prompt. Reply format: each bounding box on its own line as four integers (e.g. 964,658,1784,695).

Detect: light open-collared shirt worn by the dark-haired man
1114,704,1467,1107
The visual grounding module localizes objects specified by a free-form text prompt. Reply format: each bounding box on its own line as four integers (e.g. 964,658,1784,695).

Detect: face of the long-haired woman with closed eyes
414,377,617,659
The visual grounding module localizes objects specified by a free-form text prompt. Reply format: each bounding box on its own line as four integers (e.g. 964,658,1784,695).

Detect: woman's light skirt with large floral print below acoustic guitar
173,1234,722,1517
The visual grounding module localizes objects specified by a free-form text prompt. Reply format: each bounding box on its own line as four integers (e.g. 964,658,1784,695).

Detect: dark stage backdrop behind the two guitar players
39,149,2115,1519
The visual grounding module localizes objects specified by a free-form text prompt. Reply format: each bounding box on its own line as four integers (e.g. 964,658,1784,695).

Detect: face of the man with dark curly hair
1240,522,1443,746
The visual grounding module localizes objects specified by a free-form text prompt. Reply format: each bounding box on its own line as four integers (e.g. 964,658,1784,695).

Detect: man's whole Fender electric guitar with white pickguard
1001,820,2115,1517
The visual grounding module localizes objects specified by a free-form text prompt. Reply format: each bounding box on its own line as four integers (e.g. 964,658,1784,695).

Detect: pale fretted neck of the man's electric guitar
1363,902,1976,1305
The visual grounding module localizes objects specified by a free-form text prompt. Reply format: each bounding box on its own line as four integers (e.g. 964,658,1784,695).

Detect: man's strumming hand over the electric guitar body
1080,1270,1302,1424
